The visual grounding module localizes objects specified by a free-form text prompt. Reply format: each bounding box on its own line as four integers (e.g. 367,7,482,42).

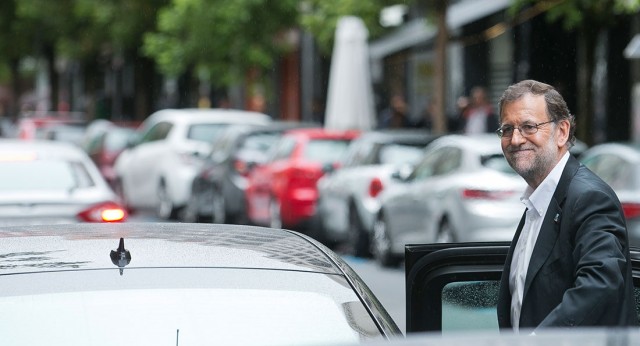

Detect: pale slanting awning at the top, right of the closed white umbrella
369,0,512,60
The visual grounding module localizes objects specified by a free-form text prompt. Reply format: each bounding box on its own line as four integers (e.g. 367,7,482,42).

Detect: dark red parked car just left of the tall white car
83,123,136,188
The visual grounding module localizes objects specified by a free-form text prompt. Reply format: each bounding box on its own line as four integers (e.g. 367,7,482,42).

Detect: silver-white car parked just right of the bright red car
318,130,436,257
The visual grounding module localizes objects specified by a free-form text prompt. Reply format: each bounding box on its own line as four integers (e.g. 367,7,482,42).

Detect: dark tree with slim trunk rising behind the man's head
510,0,640,145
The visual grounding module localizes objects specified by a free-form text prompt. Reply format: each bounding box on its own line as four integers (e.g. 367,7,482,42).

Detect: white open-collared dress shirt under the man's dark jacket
509,152,569,331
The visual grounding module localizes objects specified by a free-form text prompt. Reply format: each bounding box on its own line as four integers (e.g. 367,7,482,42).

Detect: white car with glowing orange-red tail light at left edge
0,139,127,225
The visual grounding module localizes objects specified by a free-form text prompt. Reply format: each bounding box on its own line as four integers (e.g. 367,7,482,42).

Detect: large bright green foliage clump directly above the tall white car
143,0,298,85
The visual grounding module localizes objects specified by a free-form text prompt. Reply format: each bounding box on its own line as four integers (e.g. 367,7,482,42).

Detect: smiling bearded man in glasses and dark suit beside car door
497,80,638,332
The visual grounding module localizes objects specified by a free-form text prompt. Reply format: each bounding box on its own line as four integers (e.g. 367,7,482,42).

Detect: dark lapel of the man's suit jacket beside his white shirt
524,156,580,297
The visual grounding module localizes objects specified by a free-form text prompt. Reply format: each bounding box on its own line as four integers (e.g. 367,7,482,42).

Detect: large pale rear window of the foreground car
0,268,381,345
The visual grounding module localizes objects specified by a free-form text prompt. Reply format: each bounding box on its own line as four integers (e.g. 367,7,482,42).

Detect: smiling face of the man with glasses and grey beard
501,94,569,188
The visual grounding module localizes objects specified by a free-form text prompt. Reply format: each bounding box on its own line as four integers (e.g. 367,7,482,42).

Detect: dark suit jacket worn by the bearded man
498,157,638,329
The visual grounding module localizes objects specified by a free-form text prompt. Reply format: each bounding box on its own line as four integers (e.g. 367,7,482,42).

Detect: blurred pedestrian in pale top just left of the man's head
462,86,498,134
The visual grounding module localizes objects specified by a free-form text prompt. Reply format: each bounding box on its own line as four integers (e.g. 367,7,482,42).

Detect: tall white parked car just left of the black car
115,109,271,219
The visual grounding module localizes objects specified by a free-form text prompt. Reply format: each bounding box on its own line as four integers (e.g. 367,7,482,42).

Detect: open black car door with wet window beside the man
405,242,640,334
